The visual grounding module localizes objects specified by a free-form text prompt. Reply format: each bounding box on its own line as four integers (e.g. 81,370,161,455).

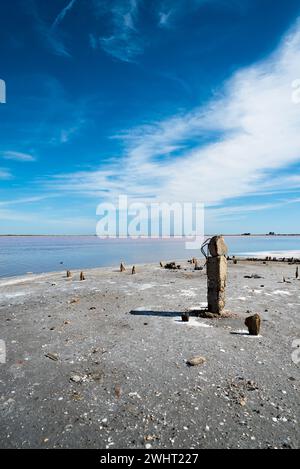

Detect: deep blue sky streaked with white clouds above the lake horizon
0,0,300,234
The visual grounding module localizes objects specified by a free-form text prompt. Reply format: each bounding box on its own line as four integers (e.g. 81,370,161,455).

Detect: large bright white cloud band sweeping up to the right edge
47,18,300,212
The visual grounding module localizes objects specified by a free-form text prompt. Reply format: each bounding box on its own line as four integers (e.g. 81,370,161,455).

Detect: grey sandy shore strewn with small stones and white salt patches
0,262,300,449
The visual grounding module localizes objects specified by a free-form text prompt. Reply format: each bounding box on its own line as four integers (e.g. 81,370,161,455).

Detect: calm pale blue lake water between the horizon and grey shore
0,236,300,277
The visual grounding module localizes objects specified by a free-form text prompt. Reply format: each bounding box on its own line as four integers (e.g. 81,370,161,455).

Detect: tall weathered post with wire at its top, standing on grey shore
207,236,228,315
